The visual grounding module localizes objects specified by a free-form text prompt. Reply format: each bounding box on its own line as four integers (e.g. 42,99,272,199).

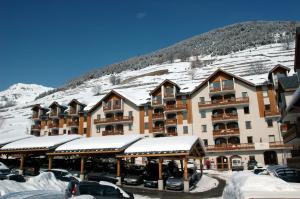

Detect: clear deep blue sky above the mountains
0,0,300,90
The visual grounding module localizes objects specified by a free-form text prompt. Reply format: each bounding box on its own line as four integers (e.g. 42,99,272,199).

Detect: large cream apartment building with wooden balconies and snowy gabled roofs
32,68,290,170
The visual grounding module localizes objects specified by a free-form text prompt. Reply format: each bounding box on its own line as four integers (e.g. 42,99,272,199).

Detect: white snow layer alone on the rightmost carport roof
125,136,199,154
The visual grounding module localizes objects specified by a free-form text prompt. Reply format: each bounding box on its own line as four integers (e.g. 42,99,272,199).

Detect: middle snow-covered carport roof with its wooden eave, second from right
48,135,142,156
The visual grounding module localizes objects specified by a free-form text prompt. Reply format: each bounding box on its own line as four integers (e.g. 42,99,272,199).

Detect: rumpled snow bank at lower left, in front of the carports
0,172,67,196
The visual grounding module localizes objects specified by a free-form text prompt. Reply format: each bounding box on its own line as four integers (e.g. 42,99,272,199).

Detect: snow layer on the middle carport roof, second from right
55,135,142,151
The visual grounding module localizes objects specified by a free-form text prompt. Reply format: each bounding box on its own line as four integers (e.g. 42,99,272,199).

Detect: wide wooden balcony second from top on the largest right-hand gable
198,97,249,109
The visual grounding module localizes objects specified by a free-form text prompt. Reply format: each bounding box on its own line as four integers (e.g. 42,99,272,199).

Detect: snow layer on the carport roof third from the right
1,135,81,150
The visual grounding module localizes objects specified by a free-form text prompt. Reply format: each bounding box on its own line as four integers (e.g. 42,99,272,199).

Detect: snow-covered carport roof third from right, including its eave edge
0,135,81,154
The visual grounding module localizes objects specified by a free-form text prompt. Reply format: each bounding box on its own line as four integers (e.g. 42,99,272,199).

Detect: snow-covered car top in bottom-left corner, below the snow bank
0,190,66,199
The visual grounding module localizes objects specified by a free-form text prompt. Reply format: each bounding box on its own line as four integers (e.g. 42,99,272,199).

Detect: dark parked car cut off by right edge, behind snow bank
267,165,300,183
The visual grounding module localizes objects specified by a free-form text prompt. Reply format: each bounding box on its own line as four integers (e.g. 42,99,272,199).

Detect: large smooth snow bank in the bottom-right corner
223,171,300,199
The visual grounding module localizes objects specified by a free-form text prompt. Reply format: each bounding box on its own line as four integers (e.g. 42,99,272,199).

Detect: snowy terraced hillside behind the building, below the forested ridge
0,44,294,136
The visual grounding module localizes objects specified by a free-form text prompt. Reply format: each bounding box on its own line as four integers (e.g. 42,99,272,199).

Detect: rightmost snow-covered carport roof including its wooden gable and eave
120,136,205,157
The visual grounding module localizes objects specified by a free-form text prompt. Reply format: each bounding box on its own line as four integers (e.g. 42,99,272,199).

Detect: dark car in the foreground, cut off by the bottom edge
74,181,134,199
